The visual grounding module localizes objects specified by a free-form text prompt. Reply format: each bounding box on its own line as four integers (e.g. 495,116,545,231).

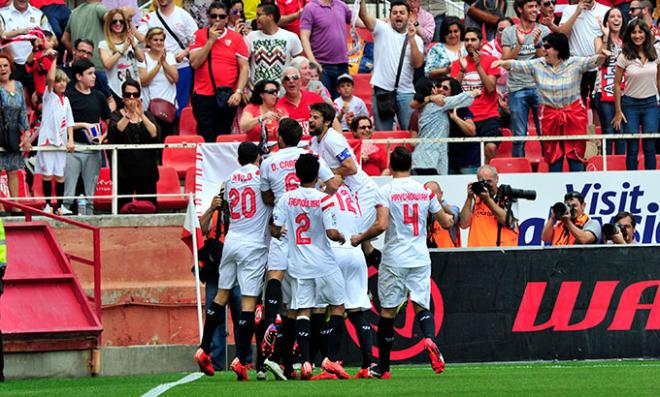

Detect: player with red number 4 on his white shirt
351,147,453,379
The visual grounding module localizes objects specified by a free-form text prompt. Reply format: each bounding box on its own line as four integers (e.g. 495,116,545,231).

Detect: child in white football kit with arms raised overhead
36,56,74,215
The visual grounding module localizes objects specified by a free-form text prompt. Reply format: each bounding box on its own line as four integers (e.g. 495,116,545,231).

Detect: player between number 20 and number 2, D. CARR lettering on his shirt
257,118,341,379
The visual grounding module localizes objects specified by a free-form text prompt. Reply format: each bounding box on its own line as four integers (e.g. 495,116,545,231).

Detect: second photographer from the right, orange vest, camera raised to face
541,192,600,245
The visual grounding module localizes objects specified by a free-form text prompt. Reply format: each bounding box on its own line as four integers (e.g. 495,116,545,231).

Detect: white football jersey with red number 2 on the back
273,187,338,279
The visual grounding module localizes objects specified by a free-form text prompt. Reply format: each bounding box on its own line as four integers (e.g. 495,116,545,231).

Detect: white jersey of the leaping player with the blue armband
310,128,375,192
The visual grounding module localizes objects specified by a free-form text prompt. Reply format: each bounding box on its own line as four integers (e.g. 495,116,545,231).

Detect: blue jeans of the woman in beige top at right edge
621,95,658,171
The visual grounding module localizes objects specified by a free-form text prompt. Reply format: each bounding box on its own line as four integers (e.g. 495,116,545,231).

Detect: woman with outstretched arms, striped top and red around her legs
492,33,605,172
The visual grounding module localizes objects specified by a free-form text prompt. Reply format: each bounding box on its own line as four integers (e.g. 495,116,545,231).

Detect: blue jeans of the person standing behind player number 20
205,281,245,370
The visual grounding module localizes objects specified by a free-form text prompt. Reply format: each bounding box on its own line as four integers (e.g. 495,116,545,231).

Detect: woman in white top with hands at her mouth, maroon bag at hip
138,27,179,140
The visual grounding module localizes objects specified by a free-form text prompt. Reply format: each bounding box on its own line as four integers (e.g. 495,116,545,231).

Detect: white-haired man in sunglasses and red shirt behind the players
277,66,326,135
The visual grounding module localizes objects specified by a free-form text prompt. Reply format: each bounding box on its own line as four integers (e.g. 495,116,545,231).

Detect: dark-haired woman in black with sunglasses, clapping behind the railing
108,79,160,213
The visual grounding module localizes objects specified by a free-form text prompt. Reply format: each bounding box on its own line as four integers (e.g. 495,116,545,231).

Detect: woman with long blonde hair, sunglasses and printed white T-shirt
99,8,144,108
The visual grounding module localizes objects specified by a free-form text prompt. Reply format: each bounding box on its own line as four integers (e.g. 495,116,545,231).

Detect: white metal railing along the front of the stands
0,133,660,215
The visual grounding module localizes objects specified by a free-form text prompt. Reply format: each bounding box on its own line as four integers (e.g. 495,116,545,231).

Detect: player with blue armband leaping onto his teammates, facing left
309,103,381,267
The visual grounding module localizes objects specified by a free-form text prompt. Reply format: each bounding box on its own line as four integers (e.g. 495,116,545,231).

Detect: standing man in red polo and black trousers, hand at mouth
190,1,249,142
